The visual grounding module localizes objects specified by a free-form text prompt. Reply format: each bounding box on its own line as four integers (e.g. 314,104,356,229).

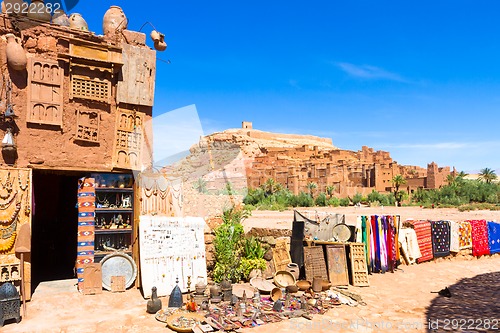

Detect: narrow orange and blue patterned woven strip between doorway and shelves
76,178,95,290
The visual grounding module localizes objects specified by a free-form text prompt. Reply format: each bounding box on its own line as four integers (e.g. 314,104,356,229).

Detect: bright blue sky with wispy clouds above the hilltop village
72,0,500,171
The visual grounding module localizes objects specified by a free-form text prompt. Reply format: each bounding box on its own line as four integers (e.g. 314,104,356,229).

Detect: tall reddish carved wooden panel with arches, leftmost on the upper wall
27,58,64,126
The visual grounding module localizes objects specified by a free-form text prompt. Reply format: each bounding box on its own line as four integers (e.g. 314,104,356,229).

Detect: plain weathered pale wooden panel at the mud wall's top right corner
116,44,156,106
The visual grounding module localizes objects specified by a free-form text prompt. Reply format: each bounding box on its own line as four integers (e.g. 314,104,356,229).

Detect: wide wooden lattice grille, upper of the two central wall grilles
69,72,111,103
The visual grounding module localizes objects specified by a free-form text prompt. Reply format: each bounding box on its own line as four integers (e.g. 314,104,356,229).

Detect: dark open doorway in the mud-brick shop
31,170,82,291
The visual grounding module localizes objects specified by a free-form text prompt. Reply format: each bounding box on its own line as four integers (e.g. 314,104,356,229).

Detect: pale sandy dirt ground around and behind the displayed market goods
0,207,500,333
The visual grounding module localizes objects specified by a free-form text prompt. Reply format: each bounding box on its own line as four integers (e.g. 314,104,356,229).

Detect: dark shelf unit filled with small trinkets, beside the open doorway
92,174,134,262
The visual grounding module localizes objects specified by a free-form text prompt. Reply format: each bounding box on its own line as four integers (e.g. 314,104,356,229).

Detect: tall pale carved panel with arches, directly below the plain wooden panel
113,109,144,170
